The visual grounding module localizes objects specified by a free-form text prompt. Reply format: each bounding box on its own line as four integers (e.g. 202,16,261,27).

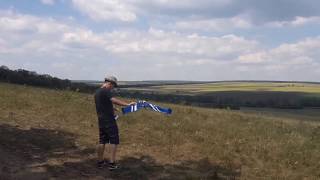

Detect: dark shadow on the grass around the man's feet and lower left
0,124,240,180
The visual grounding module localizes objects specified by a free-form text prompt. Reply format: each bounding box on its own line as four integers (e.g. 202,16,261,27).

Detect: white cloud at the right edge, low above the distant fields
236,37,320,81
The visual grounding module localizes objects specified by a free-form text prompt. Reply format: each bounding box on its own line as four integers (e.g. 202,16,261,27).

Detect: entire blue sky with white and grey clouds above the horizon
0,0,320,81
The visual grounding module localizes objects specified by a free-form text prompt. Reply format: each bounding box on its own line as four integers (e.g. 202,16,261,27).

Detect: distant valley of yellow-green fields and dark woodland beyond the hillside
120,81,320,109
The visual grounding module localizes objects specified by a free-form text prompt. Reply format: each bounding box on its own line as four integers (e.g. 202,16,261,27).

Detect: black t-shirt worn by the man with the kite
94,88,114,119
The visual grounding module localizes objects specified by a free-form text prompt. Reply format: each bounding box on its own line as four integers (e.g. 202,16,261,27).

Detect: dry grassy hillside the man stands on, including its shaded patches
0,83,320,180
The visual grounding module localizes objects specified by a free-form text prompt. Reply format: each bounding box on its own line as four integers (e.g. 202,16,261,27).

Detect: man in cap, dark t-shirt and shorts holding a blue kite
94,76,135,170
